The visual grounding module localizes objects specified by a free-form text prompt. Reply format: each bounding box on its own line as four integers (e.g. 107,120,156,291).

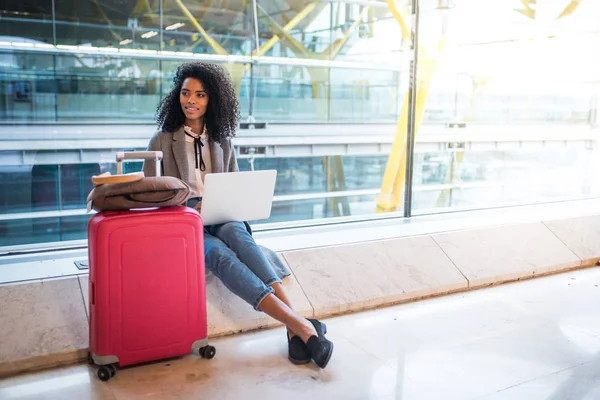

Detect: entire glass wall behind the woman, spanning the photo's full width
0,0,600,250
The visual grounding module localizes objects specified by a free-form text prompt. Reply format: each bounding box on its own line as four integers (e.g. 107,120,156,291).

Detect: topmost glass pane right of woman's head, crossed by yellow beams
257,0,402,66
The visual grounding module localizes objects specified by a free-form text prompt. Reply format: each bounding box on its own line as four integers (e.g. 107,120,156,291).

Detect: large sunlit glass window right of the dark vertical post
412,0,600,213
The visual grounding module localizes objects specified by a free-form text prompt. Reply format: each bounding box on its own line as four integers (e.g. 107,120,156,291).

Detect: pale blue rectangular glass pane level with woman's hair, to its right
255,64,400,123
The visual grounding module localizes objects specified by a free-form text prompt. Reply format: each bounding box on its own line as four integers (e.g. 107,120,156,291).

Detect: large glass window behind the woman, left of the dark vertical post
0,0,409,247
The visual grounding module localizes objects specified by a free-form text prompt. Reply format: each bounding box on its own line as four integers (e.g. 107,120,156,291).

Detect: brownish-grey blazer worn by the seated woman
143,126,239,180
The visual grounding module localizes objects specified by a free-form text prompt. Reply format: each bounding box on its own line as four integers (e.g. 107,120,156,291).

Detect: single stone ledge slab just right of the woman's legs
283,236,468,318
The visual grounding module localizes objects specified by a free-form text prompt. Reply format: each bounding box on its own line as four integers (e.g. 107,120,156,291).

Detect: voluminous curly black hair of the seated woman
156,62,240,143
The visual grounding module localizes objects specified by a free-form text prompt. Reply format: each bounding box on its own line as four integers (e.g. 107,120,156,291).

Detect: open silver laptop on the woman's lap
200,170,277,226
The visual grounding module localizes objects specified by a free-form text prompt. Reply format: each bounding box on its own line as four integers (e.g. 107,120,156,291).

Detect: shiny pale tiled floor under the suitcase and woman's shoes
0,268,600,400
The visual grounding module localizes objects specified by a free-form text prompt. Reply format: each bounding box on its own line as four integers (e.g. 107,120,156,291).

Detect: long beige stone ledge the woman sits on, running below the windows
0,215,600,377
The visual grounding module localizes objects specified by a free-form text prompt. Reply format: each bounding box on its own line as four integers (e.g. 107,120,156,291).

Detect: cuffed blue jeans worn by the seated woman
204,222,281,311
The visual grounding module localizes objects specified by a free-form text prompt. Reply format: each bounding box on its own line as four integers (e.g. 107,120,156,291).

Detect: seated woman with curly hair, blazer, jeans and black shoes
144,62,333,368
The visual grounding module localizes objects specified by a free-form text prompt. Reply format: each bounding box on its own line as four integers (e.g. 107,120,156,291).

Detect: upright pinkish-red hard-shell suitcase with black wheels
88,152,215,381
